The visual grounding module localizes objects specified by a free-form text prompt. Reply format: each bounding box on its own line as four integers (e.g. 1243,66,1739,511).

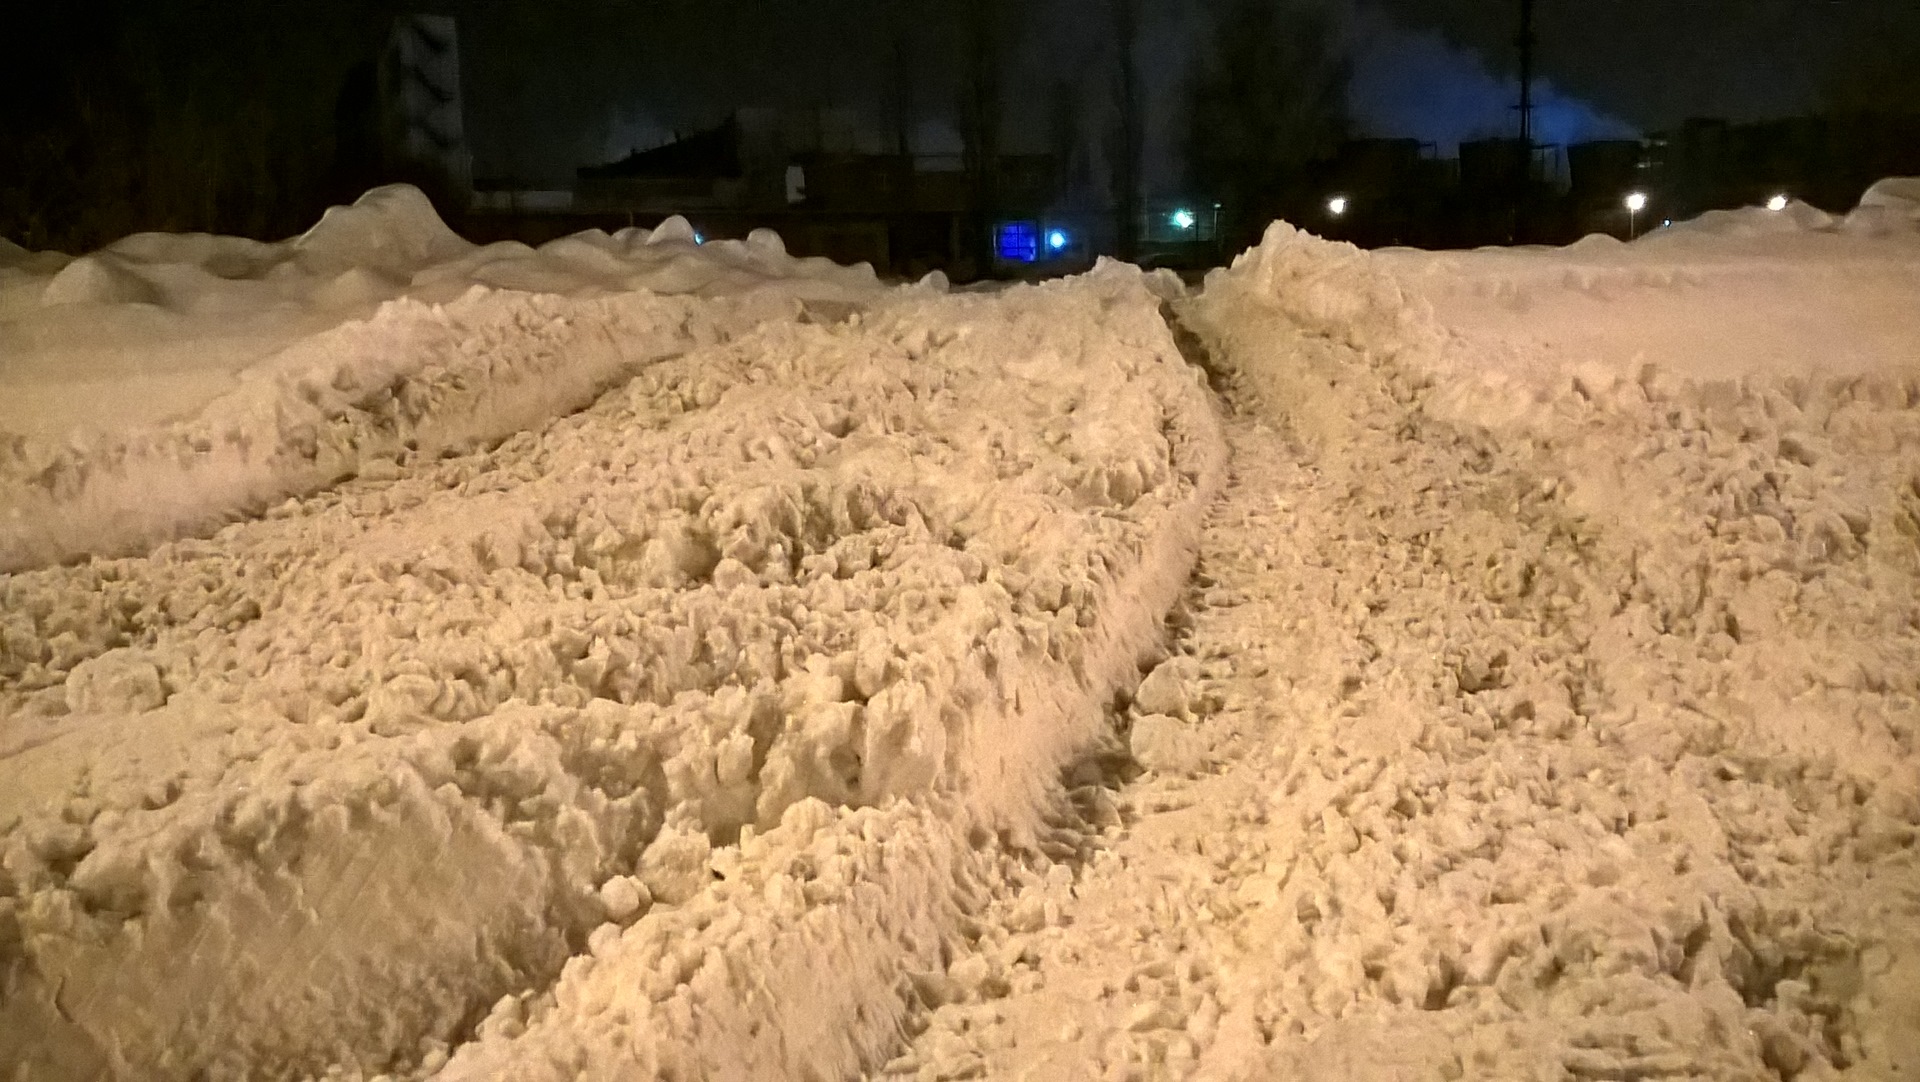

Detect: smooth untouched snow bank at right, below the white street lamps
1208,205,1920,450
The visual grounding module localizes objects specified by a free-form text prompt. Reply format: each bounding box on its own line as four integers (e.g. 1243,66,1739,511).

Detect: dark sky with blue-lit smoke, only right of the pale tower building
424,0,1920,180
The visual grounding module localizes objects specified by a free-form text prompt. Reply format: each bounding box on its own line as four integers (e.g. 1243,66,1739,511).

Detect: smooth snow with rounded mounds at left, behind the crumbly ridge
0,186,879,443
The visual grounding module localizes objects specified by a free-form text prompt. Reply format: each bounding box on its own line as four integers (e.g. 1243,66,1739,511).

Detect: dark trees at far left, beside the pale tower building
0,0,401,249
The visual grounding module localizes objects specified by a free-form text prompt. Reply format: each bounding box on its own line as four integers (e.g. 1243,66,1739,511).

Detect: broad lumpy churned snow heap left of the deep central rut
0,269,1223,1080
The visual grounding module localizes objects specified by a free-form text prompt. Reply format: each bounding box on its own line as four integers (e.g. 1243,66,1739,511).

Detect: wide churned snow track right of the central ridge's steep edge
879,282,1920,1080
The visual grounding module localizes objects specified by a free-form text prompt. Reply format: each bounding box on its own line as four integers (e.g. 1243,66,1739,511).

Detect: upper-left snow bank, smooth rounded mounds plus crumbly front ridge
0,186,879,570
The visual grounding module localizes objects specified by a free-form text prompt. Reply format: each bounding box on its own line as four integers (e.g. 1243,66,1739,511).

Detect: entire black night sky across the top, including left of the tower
8,0,1920,186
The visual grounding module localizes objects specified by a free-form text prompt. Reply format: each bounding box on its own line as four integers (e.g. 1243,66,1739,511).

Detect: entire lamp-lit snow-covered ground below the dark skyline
0,180,1920,1082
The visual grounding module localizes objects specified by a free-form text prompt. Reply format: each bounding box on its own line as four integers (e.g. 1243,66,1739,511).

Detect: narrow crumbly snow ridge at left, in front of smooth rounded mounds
0,288,721,570
